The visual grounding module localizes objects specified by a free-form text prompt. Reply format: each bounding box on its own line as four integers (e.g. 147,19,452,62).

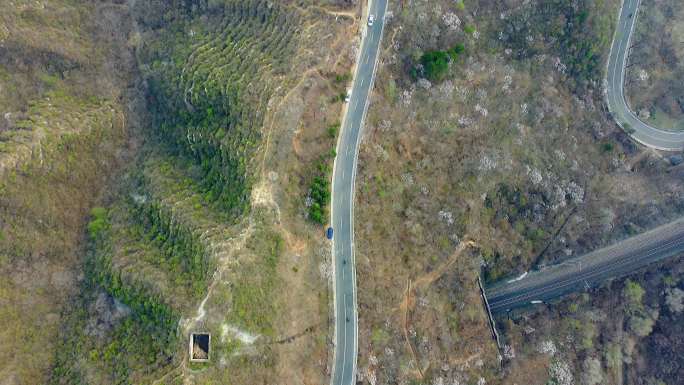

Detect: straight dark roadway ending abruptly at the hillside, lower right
485,218,684,313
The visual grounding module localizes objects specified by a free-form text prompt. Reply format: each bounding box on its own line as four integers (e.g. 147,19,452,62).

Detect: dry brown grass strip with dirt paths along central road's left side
169,3,354,384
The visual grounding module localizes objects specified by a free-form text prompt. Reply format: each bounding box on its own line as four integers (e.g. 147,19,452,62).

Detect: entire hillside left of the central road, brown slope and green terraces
0,0,357,384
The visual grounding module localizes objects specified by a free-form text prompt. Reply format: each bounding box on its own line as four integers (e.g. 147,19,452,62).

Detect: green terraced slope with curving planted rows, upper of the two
141,1,300,215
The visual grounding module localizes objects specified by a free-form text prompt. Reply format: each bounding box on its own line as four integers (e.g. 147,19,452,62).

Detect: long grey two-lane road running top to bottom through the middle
331,0,387,385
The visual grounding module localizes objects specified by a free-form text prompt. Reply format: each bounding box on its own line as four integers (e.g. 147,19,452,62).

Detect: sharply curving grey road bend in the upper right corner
606,0,684,151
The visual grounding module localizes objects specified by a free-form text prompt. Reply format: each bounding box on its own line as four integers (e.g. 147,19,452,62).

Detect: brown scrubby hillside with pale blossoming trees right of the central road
355,0,684,384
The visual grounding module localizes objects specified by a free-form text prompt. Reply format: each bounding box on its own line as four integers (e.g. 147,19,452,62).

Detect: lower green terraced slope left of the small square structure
52,158,236,384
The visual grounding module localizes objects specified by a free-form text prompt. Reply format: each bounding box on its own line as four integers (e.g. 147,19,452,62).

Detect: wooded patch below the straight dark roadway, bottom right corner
499,258,684,385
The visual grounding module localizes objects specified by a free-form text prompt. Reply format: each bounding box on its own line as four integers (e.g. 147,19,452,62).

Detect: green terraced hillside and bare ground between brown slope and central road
51,0,353,384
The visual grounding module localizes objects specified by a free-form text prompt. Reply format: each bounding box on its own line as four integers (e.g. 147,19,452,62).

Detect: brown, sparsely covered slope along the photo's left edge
0,0,136,384
